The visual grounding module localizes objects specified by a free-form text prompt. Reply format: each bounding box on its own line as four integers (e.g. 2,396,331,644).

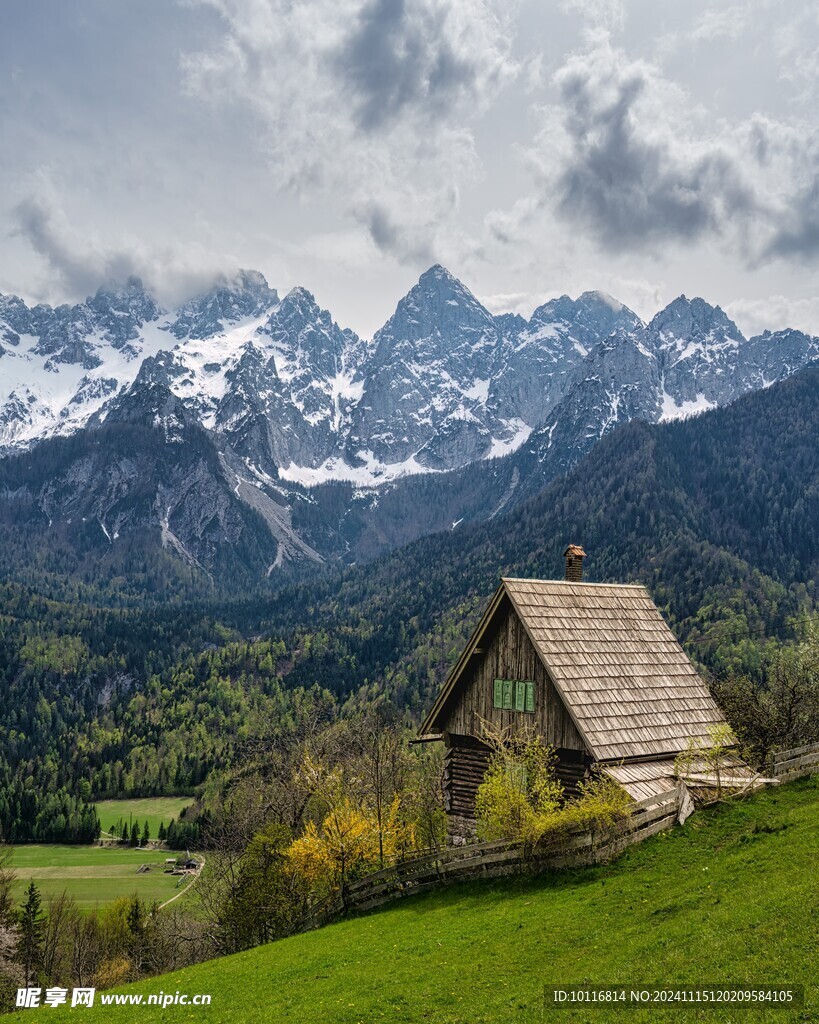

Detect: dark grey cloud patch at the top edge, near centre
335,0,483,131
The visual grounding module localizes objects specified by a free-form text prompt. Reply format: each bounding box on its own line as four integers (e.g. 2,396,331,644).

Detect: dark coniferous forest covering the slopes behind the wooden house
0,369,819,842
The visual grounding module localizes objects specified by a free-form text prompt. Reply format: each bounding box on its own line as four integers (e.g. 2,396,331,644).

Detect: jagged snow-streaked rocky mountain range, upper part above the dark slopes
0,266,818,486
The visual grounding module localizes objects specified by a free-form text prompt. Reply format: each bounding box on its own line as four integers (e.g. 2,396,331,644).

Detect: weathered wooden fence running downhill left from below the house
294,786,685,932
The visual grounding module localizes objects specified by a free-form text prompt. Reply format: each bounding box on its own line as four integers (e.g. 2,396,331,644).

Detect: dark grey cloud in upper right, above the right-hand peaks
554,47,759,249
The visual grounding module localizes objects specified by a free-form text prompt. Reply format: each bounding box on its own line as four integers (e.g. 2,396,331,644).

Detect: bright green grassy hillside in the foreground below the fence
33,779,819,1024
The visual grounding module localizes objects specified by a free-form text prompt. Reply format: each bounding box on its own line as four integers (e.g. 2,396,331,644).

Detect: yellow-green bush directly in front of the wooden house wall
476,737,631,845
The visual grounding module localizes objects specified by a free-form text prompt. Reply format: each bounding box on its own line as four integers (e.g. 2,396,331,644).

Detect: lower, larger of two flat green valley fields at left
11,844,192,910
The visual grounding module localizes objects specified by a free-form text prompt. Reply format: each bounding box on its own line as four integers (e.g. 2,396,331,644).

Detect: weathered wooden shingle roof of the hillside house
421,579,724,761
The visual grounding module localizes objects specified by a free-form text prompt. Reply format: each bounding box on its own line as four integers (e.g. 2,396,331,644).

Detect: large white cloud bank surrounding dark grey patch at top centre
182,0,518,261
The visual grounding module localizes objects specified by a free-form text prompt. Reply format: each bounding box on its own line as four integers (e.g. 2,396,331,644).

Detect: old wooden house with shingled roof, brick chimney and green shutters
419,545,748,842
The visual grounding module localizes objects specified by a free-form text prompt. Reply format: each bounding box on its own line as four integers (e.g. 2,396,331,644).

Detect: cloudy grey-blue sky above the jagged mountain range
0,0,819,335
